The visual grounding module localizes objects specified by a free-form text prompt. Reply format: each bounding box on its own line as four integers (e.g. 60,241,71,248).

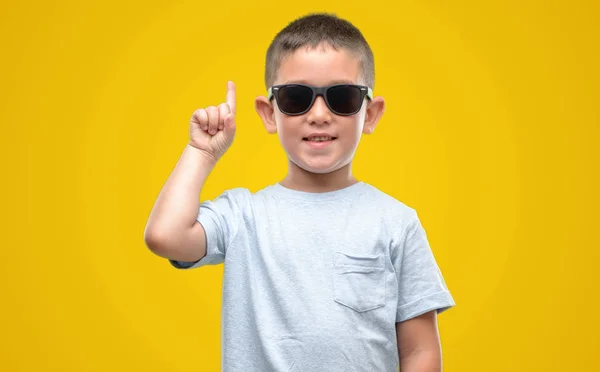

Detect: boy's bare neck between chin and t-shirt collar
280,161,358,192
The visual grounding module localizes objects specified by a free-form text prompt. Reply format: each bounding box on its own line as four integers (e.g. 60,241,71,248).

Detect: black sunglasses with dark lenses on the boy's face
268,84,373,116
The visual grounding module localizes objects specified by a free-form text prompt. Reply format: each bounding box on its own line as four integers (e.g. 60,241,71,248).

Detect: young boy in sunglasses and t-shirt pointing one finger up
145,14,455,372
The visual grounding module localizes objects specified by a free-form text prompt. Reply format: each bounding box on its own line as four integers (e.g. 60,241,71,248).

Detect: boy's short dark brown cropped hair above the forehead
265,13,375,89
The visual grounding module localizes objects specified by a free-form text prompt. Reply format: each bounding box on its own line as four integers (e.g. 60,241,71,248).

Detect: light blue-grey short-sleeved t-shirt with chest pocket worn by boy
170,182,455,372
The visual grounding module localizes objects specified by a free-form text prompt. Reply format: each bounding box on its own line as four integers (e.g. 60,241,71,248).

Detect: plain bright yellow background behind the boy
0,0,600,372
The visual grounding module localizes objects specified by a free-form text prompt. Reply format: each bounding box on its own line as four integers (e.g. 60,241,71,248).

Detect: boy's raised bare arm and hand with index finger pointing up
144,82,235,262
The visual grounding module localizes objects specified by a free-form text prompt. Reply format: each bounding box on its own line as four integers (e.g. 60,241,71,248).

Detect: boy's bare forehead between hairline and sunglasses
275,47,361,86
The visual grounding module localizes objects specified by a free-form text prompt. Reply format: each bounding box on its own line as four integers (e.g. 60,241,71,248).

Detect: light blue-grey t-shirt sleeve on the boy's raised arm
169,188,250,269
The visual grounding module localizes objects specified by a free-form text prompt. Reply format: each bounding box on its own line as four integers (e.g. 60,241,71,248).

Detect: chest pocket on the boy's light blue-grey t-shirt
333,252,386,312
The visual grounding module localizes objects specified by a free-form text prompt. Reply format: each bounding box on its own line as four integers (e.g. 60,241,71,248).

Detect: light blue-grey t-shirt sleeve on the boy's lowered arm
392,210,455,322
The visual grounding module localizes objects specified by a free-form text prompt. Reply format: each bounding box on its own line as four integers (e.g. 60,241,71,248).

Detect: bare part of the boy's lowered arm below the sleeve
396,310,442,372
